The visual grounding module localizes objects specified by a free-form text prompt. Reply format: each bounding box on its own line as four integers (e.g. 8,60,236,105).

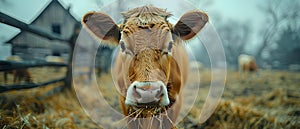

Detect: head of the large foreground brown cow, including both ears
82,6,208,115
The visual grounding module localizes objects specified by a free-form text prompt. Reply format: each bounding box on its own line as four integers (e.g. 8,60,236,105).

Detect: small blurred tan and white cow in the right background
238,54,258,75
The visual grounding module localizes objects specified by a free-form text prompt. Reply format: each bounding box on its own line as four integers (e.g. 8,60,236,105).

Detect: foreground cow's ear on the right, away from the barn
173,11,208,40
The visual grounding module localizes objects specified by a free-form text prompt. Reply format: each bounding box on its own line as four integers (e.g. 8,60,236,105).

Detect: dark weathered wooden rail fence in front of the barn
0,12,78,93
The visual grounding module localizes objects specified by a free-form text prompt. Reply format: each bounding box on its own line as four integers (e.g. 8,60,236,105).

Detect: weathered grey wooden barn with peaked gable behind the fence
2,0,79,61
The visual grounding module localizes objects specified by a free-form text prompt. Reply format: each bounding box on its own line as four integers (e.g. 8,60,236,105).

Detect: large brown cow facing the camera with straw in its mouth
82,6,208,129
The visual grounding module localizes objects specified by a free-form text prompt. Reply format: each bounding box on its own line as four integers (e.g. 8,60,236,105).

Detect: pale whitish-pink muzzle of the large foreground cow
125,81,170,106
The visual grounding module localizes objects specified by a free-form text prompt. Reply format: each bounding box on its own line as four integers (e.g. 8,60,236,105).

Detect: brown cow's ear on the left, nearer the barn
82,12,121,45
